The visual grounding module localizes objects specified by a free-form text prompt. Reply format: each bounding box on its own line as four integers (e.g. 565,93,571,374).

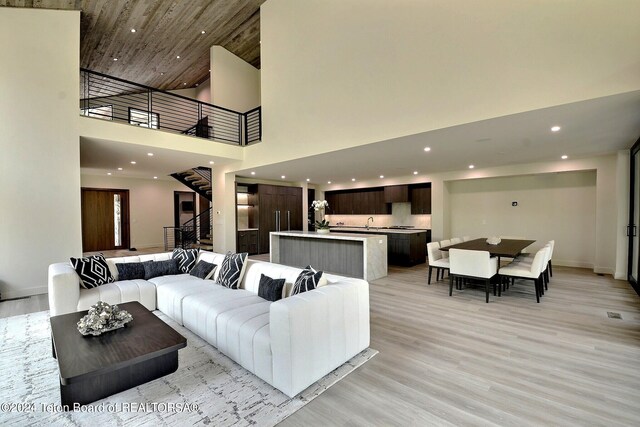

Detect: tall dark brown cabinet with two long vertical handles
258,184,302,254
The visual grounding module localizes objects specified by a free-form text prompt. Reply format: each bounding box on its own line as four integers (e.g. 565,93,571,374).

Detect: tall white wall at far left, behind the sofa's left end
0,7,82,299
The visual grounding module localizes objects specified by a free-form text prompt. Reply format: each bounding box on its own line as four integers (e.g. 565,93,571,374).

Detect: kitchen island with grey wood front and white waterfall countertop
269,231,387,280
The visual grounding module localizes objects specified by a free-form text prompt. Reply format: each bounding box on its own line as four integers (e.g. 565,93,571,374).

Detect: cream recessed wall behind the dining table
447,170,596,268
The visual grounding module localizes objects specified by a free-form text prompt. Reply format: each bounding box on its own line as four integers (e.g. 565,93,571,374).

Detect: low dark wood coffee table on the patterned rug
50,302,187,409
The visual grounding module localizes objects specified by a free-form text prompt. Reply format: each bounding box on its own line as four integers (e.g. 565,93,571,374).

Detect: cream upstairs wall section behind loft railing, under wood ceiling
211,46,260,113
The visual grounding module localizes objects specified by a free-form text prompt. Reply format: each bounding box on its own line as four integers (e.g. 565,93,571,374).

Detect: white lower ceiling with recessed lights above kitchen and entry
80,91,640,186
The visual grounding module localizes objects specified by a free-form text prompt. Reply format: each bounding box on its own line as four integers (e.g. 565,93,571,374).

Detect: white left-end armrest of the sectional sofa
48,262,80,316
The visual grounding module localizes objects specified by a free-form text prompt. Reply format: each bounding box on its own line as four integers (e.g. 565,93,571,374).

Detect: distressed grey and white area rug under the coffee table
0,311,378,426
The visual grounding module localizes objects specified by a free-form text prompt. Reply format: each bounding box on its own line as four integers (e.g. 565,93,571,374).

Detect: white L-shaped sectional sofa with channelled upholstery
48,252,369,397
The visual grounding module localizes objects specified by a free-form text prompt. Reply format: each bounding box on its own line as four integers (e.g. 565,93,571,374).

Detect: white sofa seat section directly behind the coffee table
77,279,156,311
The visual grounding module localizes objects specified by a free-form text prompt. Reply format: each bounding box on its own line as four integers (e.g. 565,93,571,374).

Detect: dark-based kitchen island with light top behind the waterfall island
331,226,431,266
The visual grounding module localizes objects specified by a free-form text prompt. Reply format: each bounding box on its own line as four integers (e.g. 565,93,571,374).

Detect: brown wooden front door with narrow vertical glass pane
81,188,129,252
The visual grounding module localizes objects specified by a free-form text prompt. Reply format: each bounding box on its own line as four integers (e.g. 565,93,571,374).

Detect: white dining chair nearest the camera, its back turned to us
449,249,498,303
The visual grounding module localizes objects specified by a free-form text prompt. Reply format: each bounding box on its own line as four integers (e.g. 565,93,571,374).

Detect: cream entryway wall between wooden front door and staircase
81,174,190,249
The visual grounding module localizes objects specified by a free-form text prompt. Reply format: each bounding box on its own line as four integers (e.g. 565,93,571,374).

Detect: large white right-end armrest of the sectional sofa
269,279,369,397
